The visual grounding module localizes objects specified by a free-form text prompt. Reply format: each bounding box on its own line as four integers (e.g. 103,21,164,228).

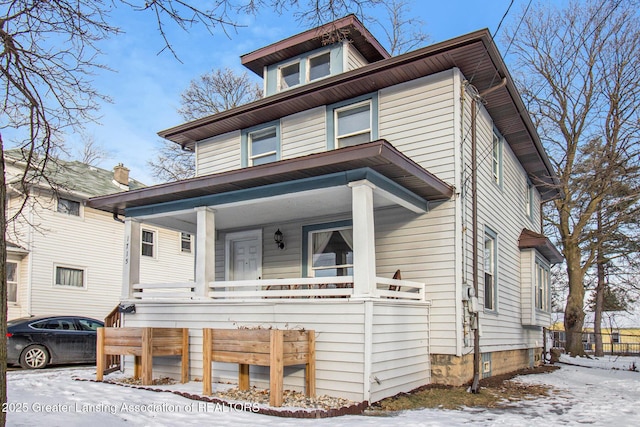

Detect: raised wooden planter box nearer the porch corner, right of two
202,328,316,406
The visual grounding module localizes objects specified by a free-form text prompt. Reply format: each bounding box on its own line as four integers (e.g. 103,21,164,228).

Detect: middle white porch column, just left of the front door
195,206,216,297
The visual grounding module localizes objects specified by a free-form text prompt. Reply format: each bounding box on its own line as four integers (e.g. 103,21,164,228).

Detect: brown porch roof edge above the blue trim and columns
86,140,454,215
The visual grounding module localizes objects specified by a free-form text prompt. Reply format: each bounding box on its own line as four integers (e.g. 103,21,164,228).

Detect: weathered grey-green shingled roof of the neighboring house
4,148,145,198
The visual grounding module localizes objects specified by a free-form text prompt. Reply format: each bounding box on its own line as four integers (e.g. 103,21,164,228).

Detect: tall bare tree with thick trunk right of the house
507,0,640,356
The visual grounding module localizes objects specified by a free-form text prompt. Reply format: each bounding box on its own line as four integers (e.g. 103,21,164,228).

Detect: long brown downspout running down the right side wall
471,77,507,393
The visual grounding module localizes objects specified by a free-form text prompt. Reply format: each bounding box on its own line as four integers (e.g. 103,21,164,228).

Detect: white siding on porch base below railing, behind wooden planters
125,300,430,402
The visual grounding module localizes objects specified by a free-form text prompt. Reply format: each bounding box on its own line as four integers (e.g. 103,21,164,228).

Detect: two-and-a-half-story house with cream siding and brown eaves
88,15,561,402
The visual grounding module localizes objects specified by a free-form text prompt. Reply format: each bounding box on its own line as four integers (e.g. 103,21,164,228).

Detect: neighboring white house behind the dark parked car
5,149,193,319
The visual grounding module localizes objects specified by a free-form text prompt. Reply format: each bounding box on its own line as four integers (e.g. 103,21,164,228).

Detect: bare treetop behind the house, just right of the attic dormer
371,0,430,56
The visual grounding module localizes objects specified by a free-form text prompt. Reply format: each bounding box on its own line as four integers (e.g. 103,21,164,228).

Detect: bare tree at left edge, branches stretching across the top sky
0,0,379,426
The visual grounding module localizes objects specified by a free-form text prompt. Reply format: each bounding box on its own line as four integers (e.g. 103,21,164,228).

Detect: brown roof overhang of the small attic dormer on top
240,14,391,76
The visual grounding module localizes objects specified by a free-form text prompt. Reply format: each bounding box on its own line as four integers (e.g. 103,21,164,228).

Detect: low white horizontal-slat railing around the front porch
133,276,426,301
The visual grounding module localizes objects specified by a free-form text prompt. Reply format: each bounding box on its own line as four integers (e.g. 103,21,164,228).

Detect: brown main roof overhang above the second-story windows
158,29,560,201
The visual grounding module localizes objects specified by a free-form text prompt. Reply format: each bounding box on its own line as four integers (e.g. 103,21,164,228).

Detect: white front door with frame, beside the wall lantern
226,230,262,280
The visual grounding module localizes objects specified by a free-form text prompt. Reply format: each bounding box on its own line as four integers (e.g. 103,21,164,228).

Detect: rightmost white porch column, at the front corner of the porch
349,180,376,298
